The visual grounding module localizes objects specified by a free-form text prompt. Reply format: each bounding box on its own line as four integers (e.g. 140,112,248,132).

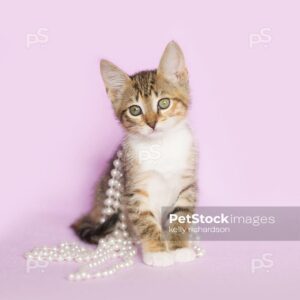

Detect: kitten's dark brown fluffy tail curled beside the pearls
71,213,119,244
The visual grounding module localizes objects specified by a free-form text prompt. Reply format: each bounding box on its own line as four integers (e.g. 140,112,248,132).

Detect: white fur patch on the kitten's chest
128,125,193,211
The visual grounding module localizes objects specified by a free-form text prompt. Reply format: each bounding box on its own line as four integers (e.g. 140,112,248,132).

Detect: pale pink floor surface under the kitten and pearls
0,213,300,300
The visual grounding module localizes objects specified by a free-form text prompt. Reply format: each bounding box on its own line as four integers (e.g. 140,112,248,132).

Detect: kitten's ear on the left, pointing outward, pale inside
100,59,131,100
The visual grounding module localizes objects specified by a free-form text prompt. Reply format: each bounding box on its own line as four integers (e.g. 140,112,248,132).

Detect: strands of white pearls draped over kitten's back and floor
25,150,203,281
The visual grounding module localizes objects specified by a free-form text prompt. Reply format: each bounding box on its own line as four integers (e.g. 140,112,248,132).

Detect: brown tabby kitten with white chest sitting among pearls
72,41,197,266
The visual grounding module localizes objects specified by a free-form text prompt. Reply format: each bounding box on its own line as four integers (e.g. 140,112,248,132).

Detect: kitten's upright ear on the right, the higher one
157,41,188,84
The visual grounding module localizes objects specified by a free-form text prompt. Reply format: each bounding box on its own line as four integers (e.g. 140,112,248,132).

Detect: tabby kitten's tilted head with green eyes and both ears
100,41,189,136
